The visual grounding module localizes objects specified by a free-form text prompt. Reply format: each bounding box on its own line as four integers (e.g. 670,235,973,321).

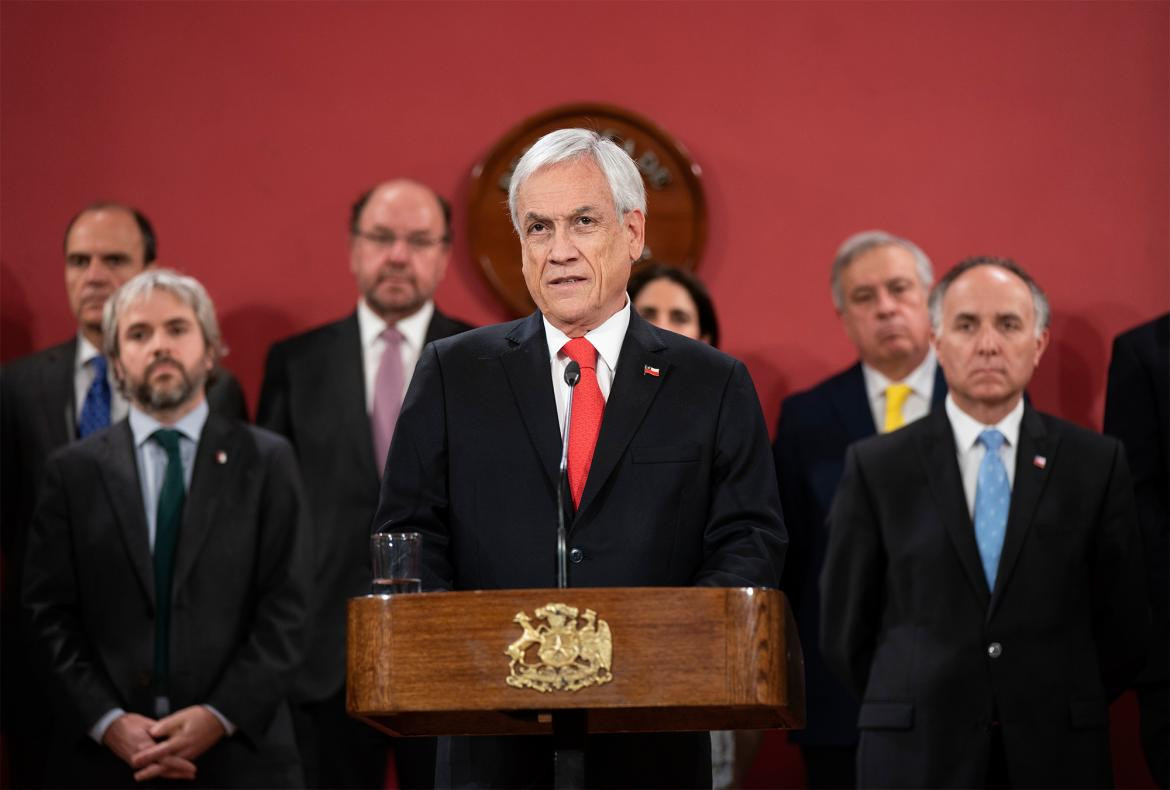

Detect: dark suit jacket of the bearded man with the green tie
25,413,310,786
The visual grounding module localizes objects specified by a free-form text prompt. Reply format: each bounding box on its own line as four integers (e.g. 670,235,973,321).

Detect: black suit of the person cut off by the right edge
1104,314,1170,788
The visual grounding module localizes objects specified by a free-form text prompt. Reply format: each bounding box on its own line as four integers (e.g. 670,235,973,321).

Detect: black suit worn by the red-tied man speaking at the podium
374,312,786,786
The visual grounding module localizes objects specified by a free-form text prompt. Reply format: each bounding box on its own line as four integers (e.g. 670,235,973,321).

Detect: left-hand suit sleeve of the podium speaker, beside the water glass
372,343,455,591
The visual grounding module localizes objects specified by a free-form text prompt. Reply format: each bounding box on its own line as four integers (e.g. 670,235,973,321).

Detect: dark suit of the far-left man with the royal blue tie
0,337,248,786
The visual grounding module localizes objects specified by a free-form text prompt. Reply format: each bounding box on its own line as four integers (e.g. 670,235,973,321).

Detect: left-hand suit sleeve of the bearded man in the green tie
23,459,124,729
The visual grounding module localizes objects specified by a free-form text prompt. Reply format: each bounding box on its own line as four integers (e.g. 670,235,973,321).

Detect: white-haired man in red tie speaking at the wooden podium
374,129,786,786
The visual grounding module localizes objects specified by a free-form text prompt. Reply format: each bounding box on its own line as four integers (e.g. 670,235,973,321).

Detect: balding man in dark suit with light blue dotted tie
820,257,1148,788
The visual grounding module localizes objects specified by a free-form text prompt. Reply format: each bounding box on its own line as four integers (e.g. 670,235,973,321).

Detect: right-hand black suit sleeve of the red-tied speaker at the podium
695,362,787,588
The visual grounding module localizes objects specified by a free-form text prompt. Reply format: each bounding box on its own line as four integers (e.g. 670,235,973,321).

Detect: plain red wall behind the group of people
0,0,1170,778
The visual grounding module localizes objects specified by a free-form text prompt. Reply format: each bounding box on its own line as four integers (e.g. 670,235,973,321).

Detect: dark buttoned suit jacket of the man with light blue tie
821,406,1148,786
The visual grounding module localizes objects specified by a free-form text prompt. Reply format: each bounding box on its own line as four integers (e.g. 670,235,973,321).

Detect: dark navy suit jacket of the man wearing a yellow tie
772,362,947,746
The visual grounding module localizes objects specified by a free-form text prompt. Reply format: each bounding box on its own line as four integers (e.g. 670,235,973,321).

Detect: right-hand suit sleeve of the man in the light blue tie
1092,442,1150,695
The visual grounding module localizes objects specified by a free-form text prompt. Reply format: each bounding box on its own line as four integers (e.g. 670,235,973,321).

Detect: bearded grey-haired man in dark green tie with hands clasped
23,269,311,786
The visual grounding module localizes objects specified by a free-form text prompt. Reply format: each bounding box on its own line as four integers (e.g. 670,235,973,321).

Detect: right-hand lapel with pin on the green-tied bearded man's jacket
172,413,245,590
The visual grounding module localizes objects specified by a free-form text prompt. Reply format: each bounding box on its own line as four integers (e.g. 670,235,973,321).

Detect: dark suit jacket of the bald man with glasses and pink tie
256,310,470,700
